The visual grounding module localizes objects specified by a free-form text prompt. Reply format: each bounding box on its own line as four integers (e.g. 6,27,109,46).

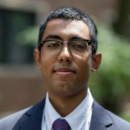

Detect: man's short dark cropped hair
38,7,98,56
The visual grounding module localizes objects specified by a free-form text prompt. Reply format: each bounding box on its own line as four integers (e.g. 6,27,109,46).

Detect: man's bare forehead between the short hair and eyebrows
42,19,90,40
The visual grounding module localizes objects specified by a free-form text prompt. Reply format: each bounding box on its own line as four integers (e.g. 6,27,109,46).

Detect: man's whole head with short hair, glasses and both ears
34,7,101,96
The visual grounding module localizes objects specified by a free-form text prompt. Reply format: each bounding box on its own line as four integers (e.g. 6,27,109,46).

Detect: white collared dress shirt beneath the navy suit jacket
41,89,93,130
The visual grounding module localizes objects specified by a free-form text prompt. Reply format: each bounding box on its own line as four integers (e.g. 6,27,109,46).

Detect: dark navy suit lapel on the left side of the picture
13,99,45,130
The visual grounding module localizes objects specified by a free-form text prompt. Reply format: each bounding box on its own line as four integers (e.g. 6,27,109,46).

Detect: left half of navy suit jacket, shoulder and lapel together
0,99,45,130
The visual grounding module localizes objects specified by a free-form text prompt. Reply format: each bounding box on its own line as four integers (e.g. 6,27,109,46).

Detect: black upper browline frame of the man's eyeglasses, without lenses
38,39,95,55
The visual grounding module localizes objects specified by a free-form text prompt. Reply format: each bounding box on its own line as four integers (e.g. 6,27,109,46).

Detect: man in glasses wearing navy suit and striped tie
0,7,130,130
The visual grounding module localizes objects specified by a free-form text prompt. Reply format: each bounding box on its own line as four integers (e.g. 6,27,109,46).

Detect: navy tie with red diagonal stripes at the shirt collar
52,119,71,130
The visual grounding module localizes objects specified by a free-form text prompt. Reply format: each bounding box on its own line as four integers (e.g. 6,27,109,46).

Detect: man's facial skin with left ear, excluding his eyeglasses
34,19,101,96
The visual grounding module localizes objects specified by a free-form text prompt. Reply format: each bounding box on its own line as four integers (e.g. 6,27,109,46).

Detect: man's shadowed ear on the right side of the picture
91,53,102,72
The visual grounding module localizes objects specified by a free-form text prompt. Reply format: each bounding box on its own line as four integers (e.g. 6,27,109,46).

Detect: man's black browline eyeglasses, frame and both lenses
38,39,93,56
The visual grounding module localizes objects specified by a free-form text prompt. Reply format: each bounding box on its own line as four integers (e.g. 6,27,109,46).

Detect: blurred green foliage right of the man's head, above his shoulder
90,25,130,111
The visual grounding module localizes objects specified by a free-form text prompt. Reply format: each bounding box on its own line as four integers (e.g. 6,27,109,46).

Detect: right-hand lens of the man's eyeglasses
70,40,88,55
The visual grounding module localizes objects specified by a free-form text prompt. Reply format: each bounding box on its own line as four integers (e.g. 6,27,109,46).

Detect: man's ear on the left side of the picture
34,49,41,70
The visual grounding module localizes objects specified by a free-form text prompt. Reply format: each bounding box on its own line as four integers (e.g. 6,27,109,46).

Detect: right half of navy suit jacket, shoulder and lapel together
90,101,130,130
